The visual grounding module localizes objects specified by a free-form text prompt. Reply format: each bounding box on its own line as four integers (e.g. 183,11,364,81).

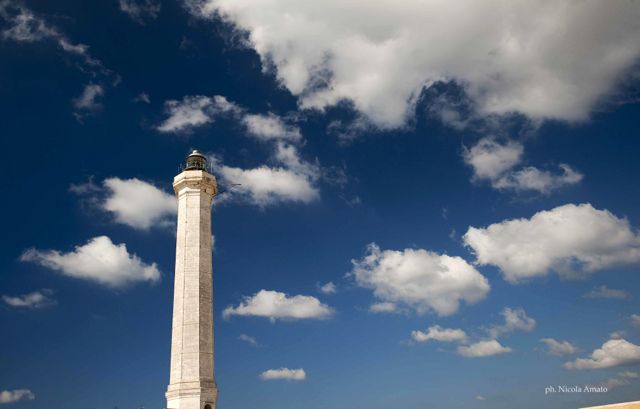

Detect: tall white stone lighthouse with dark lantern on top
166,150,218,409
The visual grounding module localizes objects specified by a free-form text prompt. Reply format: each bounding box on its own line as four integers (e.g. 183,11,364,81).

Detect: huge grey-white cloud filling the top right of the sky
184,0,640,127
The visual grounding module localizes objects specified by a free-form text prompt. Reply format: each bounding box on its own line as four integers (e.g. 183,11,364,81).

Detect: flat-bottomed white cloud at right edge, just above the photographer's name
563,339,640,369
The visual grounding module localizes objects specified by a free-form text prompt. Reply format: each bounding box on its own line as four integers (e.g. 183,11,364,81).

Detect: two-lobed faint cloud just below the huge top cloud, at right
463,137,583,194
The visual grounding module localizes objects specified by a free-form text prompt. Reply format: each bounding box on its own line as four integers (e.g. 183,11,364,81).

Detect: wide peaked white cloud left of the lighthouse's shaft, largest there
20,236,160,288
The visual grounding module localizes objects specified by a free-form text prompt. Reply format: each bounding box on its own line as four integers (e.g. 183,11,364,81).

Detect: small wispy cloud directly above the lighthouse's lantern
156,95,238,133
